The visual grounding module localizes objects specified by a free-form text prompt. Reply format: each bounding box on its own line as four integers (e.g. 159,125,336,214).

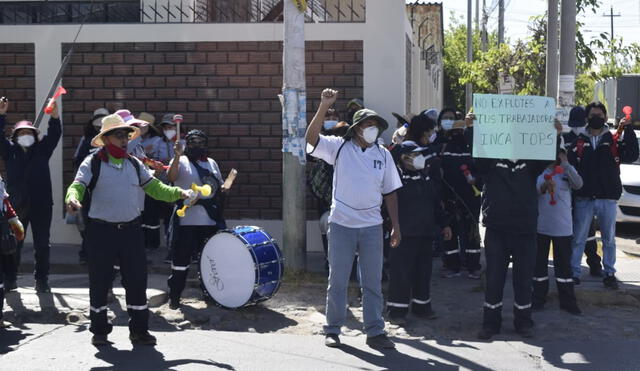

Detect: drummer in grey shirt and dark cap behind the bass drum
167,130,228,309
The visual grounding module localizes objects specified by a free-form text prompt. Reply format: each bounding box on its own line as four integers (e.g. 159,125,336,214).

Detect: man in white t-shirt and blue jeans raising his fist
305,89,402,349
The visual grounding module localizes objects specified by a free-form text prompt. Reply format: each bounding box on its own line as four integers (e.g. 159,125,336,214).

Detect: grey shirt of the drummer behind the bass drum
171,156,222,225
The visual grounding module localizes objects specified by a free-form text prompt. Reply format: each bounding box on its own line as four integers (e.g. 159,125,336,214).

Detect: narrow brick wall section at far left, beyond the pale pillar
0,44,35,176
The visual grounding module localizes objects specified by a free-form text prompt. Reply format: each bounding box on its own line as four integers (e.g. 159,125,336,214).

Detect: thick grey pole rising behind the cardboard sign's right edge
558,0,576,107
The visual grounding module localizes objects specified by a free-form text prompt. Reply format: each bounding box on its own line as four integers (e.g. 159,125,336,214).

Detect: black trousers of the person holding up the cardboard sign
482,228,536,331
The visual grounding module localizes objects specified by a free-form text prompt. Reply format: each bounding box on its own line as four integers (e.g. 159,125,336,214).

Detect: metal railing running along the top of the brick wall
0,0,366,25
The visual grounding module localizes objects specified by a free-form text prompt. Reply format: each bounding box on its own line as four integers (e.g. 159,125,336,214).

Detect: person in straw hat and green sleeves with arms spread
65,114,190,345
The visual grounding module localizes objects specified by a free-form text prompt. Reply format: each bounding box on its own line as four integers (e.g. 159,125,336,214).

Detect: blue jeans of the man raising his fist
324,223,384,337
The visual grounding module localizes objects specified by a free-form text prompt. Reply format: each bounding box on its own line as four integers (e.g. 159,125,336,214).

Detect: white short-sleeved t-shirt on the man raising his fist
307,135,402,228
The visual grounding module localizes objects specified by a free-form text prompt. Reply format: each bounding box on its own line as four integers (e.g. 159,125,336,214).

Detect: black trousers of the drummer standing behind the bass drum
167,225,218,300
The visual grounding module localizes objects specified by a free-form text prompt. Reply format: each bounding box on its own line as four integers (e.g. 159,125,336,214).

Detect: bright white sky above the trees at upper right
407,0,640,49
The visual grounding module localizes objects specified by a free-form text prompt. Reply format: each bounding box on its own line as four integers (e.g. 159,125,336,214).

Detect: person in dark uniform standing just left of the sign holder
438,108,482,279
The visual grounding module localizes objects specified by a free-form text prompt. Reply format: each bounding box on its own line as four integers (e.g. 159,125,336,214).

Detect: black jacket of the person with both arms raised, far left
0,115,62,209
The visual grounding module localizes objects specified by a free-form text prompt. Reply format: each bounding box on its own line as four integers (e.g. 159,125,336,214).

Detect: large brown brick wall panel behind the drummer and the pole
63,41,363,219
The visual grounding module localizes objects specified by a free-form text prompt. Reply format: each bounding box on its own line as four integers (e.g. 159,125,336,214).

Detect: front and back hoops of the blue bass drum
197,225,284,310
